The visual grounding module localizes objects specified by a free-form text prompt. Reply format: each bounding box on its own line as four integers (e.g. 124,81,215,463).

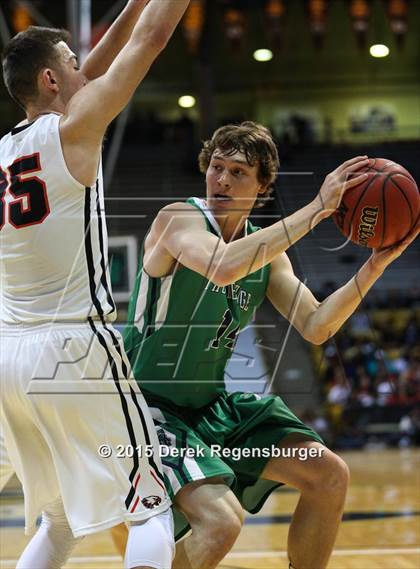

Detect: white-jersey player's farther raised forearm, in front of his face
82,0,149,81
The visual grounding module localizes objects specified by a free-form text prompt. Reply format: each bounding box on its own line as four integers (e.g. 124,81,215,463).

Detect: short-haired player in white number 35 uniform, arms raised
0,0,189,569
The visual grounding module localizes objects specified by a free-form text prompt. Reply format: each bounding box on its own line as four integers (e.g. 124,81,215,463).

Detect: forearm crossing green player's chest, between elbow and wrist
217,200,329,282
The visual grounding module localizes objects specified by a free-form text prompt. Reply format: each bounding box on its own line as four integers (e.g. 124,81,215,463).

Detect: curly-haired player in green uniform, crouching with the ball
120,122,418,569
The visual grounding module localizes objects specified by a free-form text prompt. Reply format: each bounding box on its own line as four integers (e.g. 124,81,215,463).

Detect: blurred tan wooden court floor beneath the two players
0,449,420,569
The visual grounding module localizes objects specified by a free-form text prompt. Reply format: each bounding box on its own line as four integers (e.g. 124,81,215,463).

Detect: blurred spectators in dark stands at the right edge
304,287,420,448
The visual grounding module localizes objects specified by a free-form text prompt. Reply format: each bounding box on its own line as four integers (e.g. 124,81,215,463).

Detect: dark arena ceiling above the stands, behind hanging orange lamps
0,0,420,115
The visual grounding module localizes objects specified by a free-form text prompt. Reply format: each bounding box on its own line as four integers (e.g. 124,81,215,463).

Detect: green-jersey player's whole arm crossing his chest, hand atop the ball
144,156,366,286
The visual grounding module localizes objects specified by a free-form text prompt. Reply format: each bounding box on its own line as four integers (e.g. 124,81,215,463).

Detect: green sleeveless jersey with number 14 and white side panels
124,198,270,408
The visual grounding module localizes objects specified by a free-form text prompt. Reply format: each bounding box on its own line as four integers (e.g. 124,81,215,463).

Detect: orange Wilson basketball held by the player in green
334,158,420,249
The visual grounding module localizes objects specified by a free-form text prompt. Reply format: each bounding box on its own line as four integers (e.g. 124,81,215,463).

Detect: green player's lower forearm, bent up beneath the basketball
307,258,383,343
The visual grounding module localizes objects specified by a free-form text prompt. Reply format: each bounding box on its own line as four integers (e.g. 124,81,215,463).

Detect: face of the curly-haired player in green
206,149,265,212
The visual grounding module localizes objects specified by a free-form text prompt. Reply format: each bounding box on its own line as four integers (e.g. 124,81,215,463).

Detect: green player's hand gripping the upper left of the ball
318,156,369,214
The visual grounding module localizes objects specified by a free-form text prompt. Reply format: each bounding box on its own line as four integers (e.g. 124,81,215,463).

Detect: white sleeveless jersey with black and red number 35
0,113,116,324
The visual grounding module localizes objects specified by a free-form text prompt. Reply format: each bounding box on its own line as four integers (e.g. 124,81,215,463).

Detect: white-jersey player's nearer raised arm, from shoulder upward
61,0,189,145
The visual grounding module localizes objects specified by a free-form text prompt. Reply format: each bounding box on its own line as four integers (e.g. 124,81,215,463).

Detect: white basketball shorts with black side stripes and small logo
0,320,170,537
